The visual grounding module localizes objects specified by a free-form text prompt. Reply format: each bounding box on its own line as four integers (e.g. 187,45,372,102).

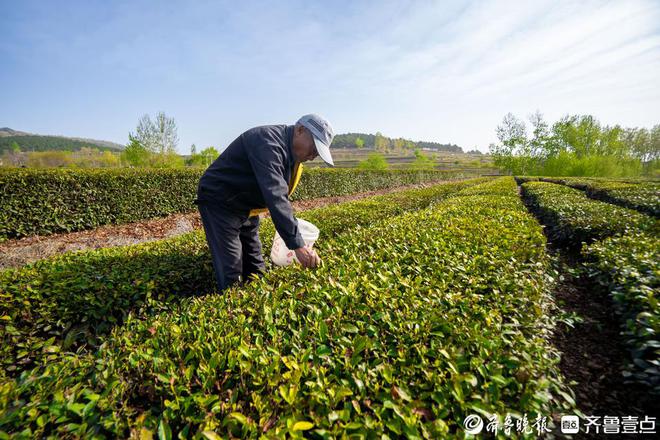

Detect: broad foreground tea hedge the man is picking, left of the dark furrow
0,178,573,438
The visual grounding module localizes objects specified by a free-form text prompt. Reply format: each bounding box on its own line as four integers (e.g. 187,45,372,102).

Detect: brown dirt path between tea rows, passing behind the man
0,180,464,269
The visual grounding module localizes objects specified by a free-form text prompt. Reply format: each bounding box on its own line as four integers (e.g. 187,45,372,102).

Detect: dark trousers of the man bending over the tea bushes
197,204,266,292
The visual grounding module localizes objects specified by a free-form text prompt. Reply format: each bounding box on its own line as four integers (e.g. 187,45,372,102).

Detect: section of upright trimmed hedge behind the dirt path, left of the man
0,168,201,239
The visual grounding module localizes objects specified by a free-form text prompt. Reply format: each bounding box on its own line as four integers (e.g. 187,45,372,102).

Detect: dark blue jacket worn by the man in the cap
195,125,305,249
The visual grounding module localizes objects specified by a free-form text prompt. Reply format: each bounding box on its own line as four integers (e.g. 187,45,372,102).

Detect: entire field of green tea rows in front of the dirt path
0,173,660,438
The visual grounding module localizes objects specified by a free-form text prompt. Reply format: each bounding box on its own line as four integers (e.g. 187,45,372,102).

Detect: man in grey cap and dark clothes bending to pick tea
195,114,334,291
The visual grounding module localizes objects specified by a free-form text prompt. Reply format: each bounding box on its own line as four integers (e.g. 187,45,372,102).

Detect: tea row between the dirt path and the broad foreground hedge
0,178,488,377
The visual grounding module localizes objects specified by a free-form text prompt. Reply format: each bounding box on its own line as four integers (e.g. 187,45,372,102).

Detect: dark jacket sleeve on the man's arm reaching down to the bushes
245,131,305,249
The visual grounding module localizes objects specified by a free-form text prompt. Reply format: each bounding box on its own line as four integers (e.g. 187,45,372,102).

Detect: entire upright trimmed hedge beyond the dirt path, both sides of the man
0,168,462,240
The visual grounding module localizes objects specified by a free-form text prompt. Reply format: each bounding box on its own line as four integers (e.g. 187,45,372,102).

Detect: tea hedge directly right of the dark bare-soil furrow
522,179,660,394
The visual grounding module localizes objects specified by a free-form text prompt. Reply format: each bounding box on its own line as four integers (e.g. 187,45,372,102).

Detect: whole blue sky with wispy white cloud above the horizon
0,0,660,153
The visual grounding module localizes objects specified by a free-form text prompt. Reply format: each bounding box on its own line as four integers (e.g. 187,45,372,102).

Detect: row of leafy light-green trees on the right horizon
489,111,660,177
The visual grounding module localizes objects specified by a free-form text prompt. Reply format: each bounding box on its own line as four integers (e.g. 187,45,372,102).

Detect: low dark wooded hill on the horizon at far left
0,127,124,153
